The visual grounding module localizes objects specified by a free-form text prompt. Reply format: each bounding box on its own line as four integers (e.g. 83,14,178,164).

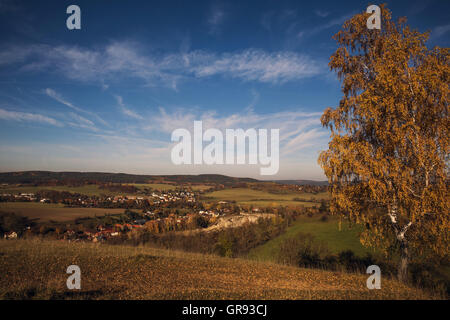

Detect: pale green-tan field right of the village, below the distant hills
205,188,328,207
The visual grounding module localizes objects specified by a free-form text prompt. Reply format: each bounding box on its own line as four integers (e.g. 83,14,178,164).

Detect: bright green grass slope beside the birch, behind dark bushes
249,217,374,261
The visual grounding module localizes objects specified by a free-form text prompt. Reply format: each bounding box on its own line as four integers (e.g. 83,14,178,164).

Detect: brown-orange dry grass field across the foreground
0,240,432,299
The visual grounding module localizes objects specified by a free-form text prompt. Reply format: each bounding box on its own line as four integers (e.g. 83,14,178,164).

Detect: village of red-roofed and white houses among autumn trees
0,190,260,242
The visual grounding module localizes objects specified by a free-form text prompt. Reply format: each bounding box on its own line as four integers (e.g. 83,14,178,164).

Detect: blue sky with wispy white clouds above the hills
0,0,450,180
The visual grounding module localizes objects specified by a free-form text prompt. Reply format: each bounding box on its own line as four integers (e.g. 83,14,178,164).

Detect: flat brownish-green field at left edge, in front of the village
0,202,124,222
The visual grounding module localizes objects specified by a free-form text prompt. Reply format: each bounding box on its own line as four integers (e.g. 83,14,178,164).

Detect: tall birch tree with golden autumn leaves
319,6,450,281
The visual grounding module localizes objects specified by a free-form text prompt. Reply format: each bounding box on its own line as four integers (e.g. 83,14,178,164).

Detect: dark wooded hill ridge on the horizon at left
0,171,258,184
